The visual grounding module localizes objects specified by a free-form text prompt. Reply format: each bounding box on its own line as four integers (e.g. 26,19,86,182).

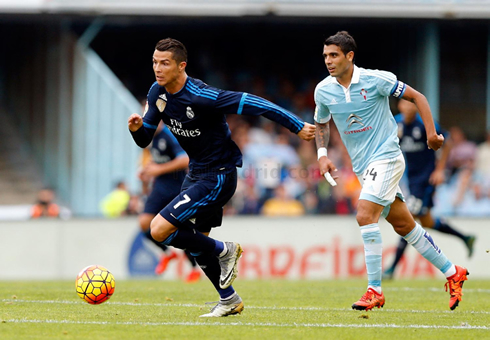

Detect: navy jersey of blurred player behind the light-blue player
395,113,446,184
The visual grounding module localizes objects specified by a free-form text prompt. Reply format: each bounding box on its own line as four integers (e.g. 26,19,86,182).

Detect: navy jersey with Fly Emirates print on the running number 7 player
131,77,304,171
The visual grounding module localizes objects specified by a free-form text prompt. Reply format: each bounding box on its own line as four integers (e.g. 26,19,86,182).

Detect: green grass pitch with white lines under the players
0,276,490,340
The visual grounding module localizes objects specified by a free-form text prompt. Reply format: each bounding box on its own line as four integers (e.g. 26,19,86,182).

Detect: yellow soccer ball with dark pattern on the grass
75,265,116,305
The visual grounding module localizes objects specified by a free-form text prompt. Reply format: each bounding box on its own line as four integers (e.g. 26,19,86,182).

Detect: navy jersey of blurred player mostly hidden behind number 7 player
151,126,186,184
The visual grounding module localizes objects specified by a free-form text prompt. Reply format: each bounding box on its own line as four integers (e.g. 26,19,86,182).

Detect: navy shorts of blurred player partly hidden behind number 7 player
143,179,183,215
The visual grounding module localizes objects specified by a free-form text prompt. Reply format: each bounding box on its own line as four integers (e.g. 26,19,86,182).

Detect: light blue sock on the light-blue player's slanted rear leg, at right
403,223,456,277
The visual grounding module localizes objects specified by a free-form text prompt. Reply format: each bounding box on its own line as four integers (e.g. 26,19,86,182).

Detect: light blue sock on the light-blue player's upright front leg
361,223,383,294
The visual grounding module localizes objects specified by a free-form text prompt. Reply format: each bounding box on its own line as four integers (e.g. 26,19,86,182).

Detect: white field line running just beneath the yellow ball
0,299,490,315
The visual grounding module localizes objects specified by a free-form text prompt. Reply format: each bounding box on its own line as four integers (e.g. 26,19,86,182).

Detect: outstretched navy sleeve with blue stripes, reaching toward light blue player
224,91,305,133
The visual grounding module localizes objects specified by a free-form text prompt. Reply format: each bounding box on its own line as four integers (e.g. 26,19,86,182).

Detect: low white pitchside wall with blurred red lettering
0,216,490,280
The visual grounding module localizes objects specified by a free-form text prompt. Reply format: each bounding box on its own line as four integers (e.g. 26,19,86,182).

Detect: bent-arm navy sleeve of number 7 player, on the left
130,82,163,148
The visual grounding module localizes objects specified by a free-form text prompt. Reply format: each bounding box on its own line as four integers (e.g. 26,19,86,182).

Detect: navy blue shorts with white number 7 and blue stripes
160,169,237,233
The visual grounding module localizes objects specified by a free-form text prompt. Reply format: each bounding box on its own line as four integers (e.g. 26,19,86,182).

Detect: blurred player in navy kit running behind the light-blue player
384,99,475,279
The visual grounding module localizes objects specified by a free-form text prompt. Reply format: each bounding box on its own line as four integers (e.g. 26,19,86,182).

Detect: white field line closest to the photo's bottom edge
2,319,490,330
